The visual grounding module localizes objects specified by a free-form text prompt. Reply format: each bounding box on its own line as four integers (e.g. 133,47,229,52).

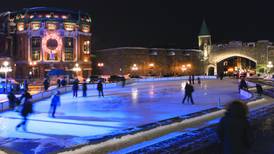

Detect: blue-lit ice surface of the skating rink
0,80,245,153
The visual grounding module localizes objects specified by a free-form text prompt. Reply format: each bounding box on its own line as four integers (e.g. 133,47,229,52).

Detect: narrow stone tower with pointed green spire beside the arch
198,20,211,60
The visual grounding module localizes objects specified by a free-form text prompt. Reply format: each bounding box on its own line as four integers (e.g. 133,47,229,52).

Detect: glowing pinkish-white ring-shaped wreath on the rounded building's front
42,32,63,54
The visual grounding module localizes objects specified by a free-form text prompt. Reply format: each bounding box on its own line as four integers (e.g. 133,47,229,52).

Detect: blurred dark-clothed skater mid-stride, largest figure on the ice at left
16,92,33,131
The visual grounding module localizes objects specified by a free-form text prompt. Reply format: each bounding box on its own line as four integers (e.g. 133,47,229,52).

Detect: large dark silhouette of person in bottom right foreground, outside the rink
217,101,251,154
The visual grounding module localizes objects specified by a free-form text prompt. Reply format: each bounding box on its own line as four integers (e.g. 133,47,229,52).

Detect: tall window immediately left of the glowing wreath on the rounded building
31,37,41,61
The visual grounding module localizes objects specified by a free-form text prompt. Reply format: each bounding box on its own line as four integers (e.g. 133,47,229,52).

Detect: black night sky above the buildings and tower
0,0,274,49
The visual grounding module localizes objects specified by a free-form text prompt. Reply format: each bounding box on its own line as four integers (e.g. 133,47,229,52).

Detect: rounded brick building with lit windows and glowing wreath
0,7,92,79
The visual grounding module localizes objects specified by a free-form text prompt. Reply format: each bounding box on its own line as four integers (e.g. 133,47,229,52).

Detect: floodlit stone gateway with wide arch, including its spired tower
198,21,274,75
